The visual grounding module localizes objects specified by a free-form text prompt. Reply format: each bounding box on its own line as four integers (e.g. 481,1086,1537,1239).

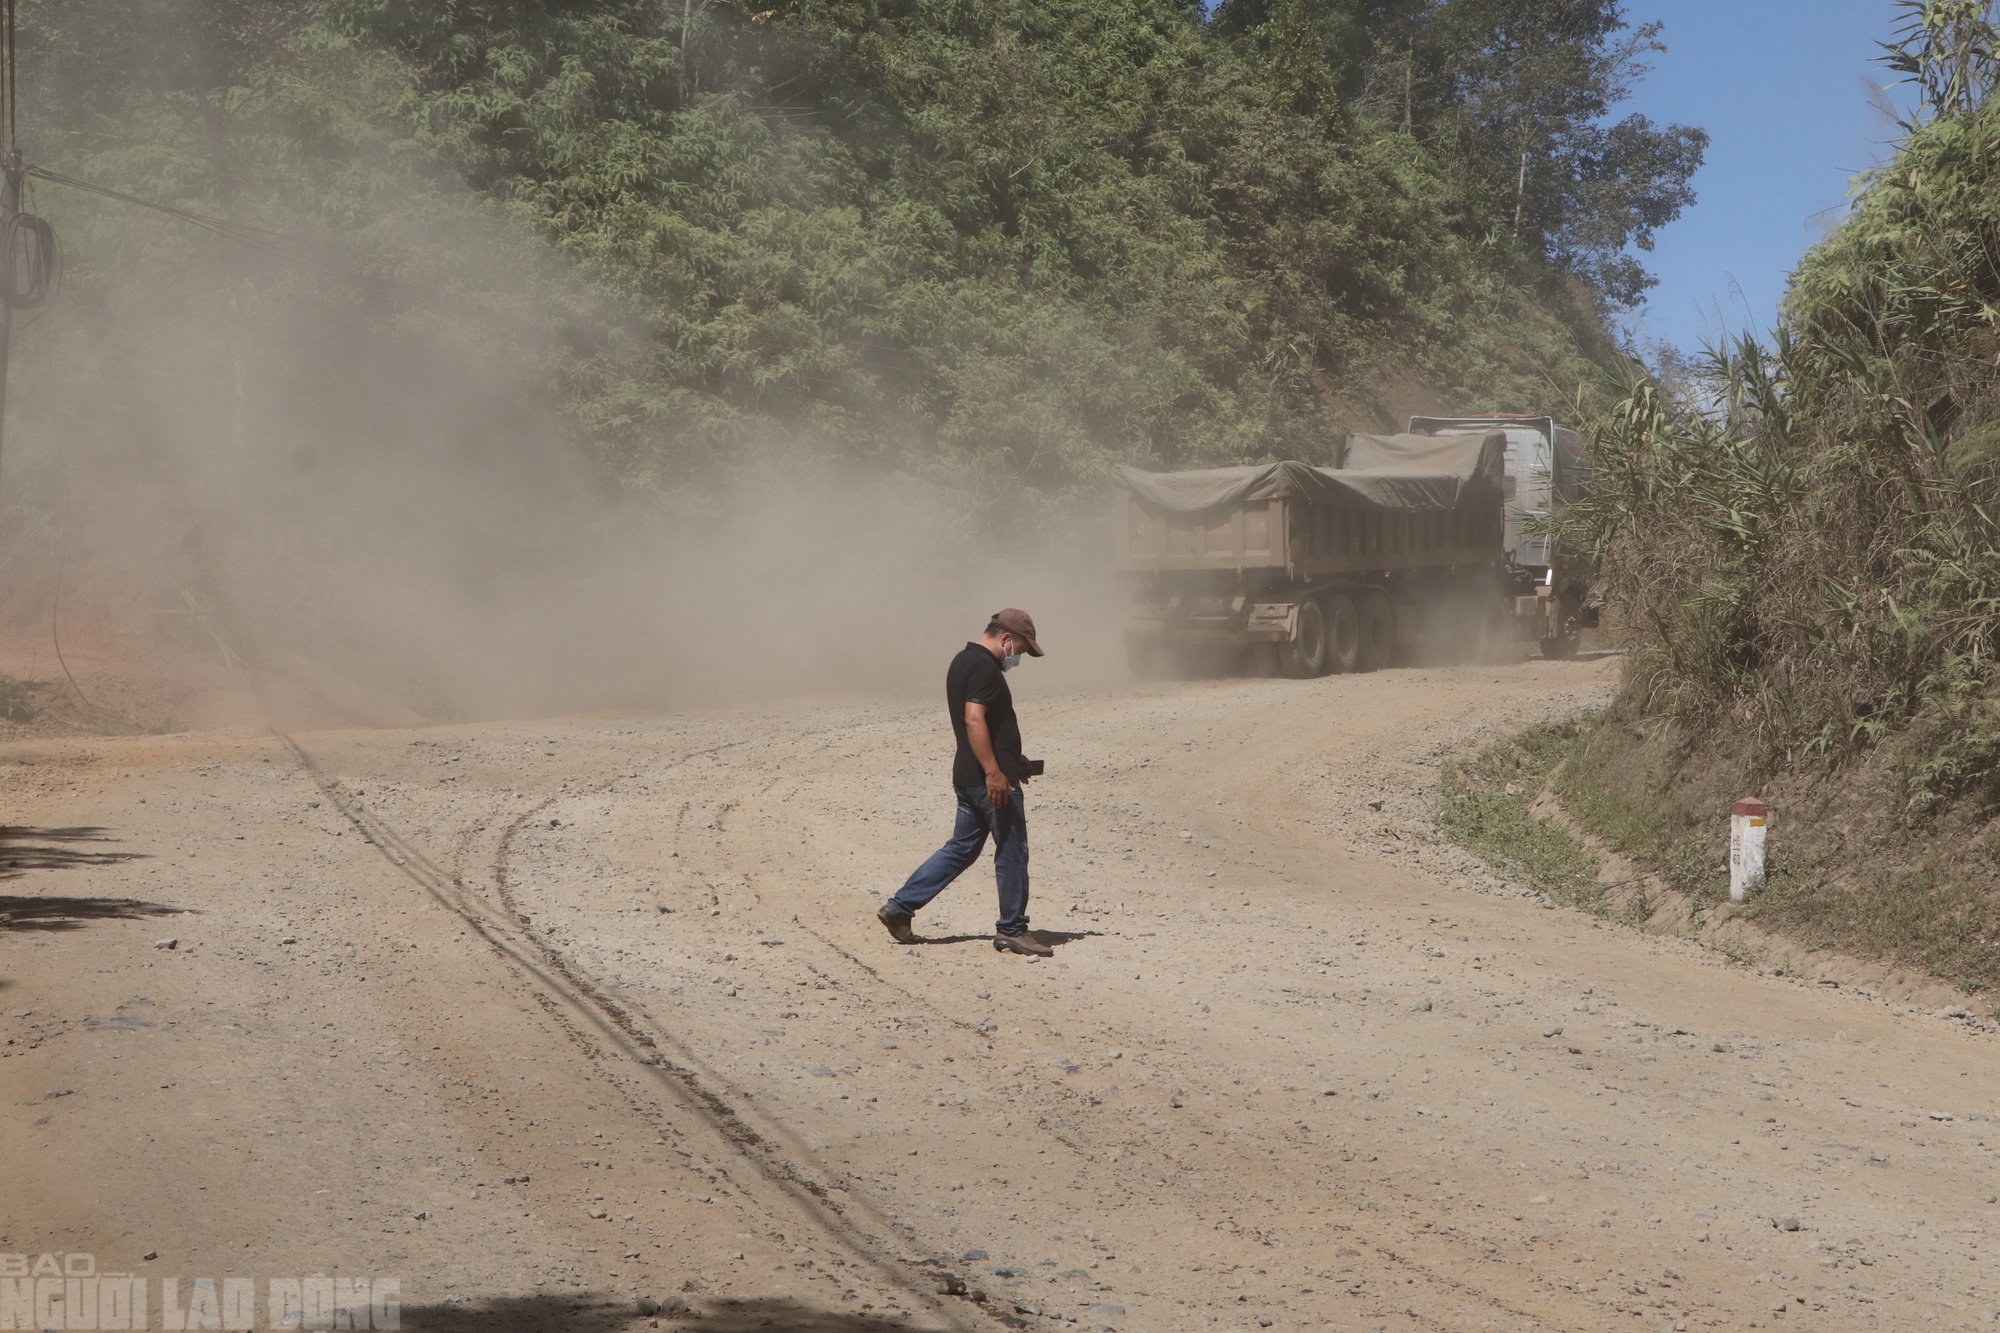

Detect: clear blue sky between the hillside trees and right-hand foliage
1618,0,1896,350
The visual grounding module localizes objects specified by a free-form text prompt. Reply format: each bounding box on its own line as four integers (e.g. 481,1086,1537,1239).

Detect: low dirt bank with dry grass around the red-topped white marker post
1542,705,2000,1000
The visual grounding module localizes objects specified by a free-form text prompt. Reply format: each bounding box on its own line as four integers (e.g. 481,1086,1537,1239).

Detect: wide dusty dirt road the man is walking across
0,662,2000,1333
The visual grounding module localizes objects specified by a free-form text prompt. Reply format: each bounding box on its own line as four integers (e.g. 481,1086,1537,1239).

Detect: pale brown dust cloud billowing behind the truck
0,200,1122,727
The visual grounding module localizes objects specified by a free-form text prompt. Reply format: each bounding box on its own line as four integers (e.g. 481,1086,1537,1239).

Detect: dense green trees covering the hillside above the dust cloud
22,0,1706,508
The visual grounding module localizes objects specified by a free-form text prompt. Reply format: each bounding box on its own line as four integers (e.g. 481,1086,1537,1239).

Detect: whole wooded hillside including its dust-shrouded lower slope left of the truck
0,0,1704,719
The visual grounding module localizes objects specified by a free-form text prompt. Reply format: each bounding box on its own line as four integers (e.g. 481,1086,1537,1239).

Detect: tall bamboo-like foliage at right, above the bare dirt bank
1570,83,2000,811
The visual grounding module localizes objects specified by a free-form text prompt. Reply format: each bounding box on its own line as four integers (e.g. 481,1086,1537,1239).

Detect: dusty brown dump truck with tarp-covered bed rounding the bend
1112,418,1574,679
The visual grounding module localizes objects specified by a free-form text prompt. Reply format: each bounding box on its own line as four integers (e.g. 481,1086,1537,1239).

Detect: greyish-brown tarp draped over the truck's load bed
1116,430,1506,514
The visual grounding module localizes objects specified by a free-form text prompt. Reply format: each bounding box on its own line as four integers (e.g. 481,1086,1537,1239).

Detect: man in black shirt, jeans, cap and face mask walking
876,606,1056,959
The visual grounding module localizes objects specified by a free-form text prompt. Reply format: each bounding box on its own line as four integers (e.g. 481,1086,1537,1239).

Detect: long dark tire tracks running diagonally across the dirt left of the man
278,733,984,1333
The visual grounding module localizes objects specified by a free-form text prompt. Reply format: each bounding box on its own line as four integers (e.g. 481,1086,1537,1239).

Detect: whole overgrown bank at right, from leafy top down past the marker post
1574,0,2000,985
